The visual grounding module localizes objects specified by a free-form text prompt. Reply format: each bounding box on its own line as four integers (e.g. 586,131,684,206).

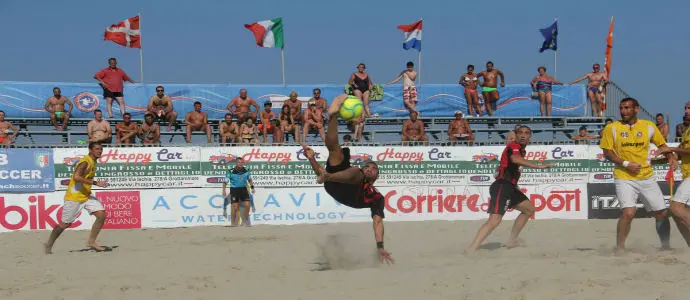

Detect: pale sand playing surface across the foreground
0,219,690,300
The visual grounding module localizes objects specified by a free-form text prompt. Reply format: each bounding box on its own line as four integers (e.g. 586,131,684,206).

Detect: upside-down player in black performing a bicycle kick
302,95,394,263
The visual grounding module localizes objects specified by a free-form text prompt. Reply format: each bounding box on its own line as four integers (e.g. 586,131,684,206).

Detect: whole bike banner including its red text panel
0,191,141,232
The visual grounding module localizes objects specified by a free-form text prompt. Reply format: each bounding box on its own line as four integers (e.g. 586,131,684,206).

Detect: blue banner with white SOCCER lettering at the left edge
0,148,55,193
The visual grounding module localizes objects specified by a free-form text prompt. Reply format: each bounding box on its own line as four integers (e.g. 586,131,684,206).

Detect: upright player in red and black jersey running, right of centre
465,126,554,252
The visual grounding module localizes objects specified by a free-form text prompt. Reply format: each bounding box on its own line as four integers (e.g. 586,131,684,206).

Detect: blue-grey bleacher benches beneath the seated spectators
7,117,604,146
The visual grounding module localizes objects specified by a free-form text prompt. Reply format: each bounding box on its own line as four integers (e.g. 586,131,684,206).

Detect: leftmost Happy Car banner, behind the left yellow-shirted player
54,147,201,190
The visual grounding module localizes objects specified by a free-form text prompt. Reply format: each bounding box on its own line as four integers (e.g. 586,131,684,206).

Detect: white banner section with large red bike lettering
0,192,93,231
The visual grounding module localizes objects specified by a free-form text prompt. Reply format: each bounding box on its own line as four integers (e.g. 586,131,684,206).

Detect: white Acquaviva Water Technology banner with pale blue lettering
141,188,360,227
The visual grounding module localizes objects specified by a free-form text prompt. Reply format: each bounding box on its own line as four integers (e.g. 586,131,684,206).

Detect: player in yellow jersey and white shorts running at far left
45,143,108,254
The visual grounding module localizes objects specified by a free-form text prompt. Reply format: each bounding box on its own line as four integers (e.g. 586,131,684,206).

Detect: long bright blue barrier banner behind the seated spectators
0,81,589,119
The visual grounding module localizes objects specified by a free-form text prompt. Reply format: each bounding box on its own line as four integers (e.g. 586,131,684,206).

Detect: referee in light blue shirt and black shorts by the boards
223,157,255,227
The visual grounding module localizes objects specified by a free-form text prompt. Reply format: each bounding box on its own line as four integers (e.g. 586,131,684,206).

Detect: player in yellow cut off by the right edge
662,102,690,246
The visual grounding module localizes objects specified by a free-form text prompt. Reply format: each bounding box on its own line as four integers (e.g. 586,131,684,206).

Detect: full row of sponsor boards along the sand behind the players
0,144,681,231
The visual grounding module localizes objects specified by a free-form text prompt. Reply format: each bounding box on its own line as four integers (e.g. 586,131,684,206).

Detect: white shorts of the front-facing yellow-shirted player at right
614,178,666,212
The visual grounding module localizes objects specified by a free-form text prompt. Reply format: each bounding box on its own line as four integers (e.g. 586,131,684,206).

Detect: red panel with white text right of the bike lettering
96,191,141,229
